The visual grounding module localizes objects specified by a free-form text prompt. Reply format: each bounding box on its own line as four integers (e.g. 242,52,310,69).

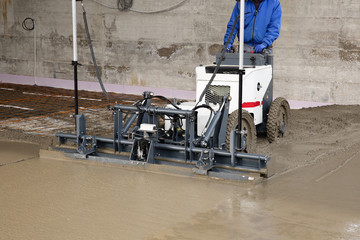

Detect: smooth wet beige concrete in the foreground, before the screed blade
0,142,360,240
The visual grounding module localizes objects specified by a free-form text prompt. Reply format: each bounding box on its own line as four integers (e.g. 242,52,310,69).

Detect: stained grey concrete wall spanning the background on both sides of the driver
0,0,360,104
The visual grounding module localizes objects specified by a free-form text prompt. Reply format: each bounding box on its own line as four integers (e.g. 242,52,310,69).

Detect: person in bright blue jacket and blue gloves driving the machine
224,0,281,53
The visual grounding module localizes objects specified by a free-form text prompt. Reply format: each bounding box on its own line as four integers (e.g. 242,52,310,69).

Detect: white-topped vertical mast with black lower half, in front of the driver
237,0,245,149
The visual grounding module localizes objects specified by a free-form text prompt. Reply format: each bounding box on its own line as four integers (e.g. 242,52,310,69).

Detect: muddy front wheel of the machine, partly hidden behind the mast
225,110,256,153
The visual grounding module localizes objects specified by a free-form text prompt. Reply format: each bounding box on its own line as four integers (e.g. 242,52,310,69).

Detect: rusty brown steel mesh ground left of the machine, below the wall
0,84,141,141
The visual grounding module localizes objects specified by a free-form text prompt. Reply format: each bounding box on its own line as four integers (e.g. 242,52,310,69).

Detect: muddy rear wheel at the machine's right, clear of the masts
266,97,290,142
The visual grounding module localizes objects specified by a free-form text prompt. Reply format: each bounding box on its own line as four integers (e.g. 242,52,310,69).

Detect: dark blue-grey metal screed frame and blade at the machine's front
56,92,270,179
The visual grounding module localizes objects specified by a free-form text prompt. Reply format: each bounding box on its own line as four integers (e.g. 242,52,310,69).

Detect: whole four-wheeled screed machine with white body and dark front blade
56,0,289,179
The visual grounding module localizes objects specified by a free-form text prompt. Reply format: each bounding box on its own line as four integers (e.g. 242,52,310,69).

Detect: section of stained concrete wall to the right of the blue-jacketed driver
275,0,360,104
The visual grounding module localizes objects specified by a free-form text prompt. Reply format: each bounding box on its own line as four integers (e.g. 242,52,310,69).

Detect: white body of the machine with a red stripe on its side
165,65,272,135
